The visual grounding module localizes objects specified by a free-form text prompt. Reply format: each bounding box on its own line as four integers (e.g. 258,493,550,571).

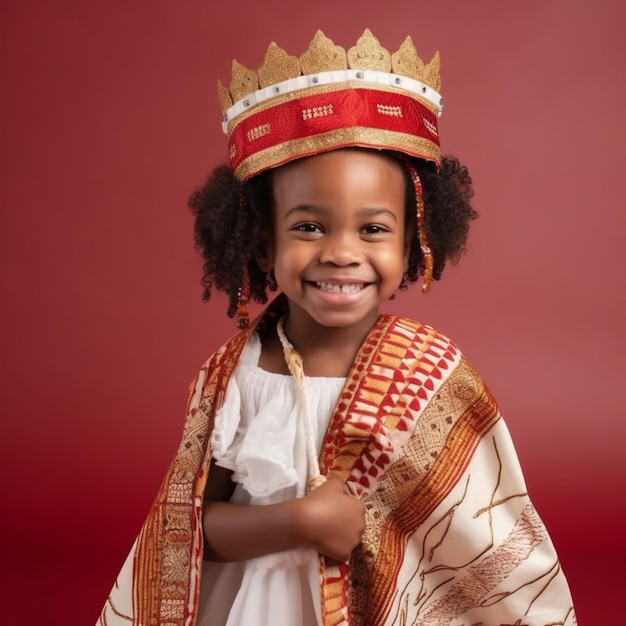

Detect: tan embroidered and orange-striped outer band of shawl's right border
362,359,500,624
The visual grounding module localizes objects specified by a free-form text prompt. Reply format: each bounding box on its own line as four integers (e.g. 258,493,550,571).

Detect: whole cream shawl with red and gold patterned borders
98,297,576,626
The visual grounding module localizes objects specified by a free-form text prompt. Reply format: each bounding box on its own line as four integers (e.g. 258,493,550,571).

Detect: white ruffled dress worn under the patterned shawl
197,334,345,626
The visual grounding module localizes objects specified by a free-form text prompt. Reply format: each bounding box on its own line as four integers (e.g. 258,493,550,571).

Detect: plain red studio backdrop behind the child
0,0,626,626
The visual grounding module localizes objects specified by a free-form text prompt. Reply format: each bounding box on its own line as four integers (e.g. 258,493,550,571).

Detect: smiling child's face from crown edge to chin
263,149,410,328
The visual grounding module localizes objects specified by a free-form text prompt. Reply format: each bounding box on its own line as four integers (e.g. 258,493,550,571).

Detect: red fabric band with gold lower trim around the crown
229,87,439,179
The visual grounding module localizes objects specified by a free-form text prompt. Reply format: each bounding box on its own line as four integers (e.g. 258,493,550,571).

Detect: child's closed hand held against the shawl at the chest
297,478,365,561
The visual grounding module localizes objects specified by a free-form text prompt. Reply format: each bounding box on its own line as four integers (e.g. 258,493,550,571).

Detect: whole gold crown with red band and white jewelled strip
218,29,442,180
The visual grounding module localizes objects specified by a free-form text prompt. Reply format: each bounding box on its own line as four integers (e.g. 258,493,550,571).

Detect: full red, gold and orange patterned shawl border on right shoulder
321,316,499,626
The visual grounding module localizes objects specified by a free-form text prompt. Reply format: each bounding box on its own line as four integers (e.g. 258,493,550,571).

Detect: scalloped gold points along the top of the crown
217,28,441,115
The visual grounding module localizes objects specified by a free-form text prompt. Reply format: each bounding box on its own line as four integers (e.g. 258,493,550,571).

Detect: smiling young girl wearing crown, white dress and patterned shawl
100,31,576,626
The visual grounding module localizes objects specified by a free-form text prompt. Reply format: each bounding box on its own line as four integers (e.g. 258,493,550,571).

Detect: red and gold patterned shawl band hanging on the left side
133,328,253,626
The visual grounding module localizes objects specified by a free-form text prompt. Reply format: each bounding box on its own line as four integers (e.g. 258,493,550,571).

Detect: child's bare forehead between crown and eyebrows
273,148,405,210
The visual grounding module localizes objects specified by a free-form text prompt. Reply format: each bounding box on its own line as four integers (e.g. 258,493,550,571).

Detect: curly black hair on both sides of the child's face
189,151,478,317
